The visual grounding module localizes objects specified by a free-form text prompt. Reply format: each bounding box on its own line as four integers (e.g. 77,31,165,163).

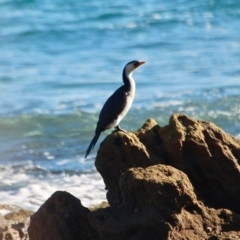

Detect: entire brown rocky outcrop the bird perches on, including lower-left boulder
29,114,240,240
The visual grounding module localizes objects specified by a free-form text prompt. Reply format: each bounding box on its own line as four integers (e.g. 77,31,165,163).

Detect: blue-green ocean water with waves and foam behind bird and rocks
0,0,240,210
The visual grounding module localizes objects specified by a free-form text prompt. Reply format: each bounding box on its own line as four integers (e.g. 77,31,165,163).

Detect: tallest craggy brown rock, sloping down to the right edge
159,114,240,213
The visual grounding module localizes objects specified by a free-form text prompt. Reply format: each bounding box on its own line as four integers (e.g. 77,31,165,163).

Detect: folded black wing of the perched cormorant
96,85,128,132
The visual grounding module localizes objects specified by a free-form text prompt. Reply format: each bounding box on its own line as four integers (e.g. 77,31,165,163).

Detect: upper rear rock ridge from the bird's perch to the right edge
96,114,240,213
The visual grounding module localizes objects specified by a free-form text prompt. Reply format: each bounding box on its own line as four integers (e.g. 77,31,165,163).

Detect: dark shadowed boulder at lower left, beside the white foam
28,191,99,240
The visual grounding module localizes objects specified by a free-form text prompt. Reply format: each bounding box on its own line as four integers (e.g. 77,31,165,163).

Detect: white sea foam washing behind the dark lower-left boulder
0,170,106,211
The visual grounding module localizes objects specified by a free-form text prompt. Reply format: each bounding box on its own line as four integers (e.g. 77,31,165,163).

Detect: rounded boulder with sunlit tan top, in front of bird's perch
120,164,197,212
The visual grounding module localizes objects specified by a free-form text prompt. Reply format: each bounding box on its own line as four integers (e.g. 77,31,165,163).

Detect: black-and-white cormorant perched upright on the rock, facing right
85,60,145,158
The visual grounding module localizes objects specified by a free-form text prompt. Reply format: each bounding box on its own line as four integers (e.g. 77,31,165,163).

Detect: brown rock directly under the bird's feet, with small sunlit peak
95,119,164,206
